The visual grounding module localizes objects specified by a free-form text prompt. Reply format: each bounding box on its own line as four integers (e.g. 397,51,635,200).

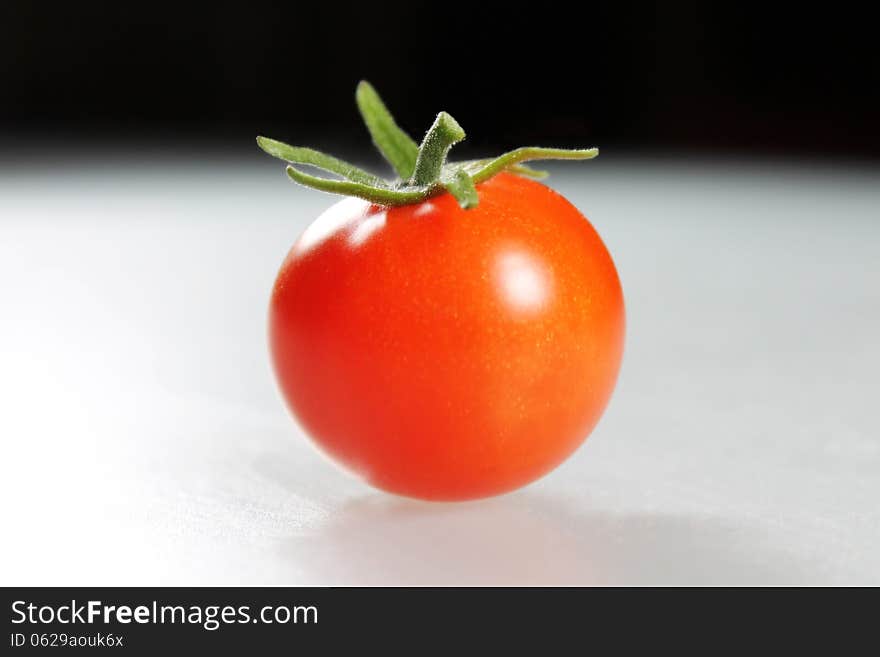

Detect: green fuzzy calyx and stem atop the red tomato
257,81,599,209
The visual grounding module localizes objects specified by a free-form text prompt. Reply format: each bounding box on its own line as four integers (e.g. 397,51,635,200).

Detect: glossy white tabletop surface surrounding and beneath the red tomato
0,157,880,585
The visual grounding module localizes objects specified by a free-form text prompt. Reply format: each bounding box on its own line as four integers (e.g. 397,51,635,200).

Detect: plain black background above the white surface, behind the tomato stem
0,0,880,159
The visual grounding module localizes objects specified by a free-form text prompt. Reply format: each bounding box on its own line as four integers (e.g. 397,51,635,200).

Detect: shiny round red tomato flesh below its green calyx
269,174,624,500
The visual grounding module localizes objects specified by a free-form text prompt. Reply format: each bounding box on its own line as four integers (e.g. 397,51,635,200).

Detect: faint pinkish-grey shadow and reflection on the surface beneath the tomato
281,490,816,586
